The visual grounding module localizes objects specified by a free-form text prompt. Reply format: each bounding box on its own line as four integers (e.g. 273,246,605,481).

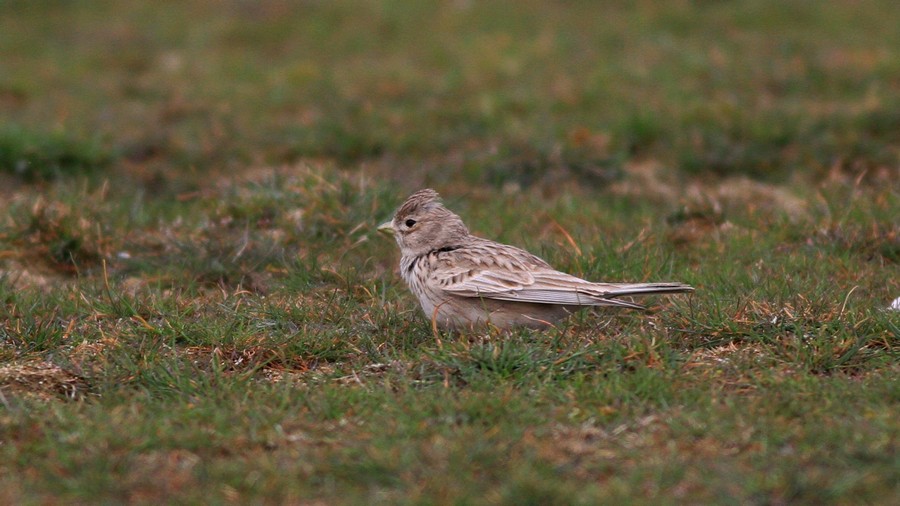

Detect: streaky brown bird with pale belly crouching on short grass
378,188,694,330
